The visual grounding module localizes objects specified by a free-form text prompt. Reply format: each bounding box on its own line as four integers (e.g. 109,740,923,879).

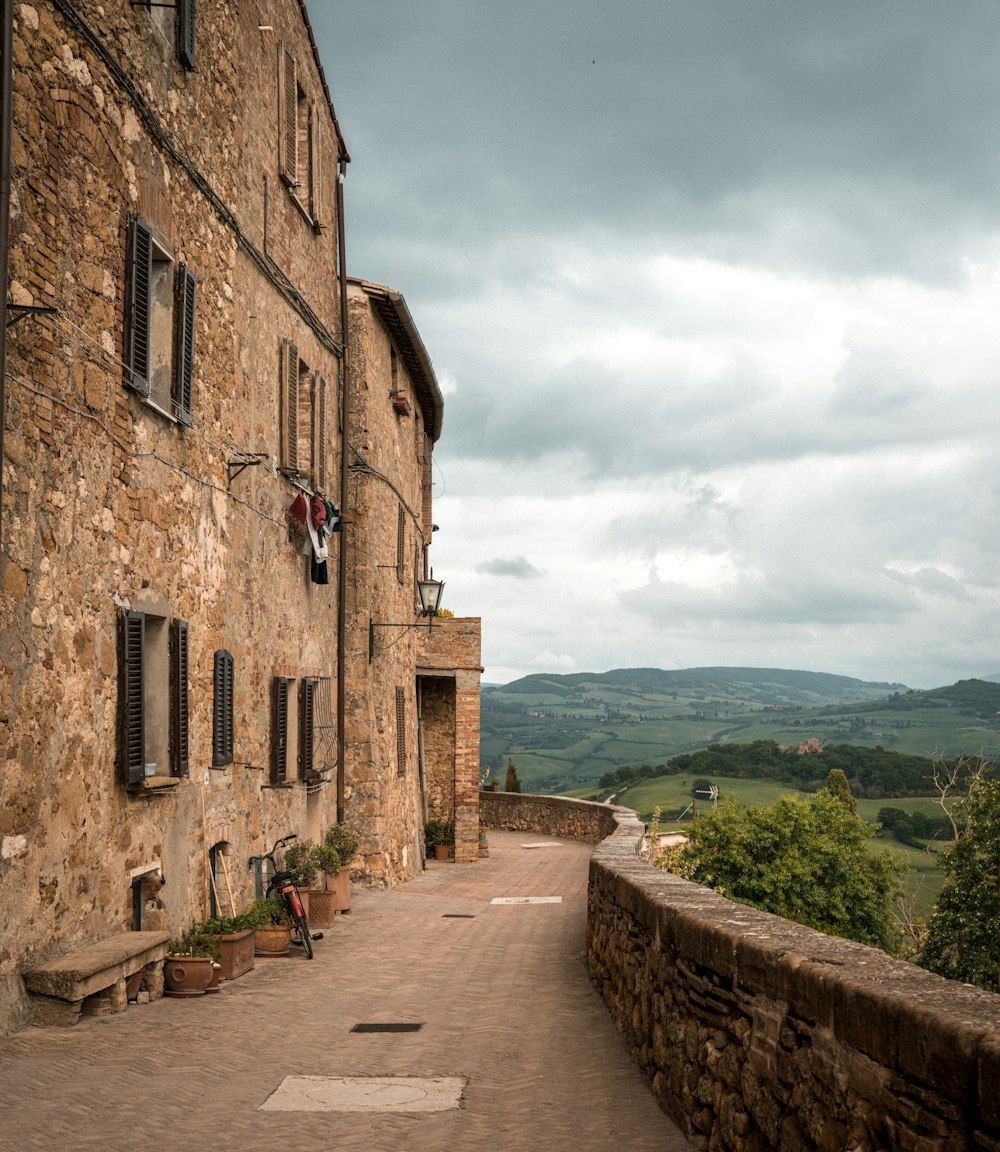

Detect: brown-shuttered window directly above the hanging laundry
281,340,331,491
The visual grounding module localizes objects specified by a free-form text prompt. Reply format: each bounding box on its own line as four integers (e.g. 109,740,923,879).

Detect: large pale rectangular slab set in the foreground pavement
258,1076,469,1112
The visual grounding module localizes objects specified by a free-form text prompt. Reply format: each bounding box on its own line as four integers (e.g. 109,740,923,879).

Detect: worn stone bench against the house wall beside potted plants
23,932,171,1024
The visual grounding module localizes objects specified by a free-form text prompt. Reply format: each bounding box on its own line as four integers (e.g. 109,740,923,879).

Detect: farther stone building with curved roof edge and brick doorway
344,278,482,882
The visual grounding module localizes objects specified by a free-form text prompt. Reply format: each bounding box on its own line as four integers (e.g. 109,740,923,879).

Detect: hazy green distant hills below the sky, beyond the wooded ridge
480,668,1000,791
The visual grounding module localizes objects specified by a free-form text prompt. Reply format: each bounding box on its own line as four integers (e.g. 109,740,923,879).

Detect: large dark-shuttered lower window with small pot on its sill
119,609,189,785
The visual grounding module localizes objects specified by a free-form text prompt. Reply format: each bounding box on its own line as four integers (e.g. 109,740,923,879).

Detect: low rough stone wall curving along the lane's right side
589,797,1000,1152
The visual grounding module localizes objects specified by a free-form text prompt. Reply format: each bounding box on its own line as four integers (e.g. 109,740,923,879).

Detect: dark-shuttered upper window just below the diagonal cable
122,217,198,424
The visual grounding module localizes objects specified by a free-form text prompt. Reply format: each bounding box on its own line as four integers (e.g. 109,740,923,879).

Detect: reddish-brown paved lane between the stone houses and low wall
0,833,690,1152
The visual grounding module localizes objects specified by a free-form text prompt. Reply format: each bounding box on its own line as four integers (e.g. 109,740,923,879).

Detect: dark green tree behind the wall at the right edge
918,779,1000,992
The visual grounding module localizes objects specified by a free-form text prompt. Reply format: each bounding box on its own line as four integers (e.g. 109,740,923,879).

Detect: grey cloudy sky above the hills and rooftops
310,0,1000,688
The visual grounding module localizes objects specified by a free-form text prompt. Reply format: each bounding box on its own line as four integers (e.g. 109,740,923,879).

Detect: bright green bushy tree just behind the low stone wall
667,789,906,952
